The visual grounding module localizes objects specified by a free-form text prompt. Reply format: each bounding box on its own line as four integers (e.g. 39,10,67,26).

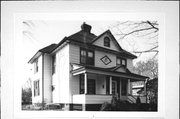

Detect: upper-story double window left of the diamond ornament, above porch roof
80,48,94,65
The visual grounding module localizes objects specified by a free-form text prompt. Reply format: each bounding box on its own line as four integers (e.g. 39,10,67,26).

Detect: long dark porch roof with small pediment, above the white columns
71,65,148,81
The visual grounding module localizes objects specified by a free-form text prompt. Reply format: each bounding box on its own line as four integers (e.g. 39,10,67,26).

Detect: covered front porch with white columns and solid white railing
72,64,146,109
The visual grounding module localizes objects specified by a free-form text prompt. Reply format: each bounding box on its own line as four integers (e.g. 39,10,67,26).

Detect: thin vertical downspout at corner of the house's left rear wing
42,53,44,109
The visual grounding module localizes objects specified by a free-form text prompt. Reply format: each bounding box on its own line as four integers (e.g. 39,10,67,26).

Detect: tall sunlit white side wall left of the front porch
53,45,71,103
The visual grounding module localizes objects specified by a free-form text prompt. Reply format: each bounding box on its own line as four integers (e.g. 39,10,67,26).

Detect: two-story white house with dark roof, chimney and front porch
29,23,147,110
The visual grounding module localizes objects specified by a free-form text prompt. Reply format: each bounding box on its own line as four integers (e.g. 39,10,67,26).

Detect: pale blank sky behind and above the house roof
22,20,158,85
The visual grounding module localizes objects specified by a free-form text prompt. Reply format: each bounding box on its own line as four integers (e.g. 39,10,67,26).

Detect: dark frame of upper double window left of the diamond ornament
80,48,94,66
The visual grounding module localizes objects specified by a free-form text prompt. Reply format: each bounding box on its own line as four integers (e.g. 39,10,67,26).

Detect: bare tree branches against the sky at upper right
110,21,159,57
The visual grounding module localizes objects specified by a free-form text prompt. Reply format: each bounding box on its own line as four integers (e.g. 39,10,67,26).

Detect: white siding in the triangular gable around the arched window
93,33,119,51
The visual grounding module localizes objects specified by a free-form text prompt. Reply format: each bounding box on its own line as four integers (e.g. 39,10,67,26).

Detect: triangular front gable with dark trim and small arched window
92,30,122,51
